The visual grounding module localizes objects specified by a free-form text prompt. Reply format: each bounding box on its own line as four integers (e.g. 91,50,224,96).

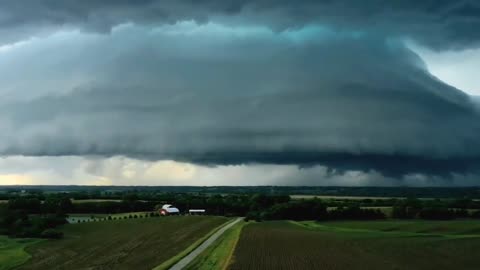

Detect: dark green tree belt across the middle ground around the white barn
0,193,480,238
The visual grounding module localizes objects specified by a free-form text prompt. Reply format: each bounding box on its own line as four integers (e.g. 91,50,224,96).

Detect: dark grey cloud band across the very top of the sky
0,0,480,50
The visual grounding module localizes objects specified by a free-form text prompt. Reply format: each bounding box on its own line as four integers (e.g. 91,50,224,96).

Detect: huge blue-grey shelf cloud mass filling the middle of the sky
0,23,480,177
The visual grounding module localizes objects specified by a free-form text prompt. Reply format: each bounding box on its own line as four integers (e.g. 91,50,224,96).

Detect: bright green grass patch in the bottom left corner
0,236,41,270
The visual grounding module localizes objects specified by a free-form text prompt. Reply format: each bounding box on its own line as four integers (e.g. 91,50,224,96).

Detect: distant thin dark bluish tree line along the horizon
0,186,480,200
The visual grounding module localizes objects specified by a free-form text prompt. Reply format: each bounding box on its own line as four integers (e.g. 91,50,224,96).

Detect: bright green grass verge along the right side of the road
185,221,246,270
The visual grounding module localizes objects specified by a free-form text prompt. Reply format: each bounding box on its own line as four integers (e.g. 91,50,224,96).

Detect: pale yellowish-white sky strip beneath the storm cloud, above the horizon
0,156,478,186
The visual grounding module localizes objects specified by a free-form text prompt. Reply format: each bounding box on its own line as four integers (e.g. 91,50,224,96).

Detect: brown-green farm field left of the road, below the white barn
15,216,228,270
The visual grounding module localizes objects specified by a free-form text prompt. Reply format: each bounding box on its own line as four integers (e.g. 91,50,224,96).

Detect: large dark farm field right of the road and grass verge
229,221,480,270
